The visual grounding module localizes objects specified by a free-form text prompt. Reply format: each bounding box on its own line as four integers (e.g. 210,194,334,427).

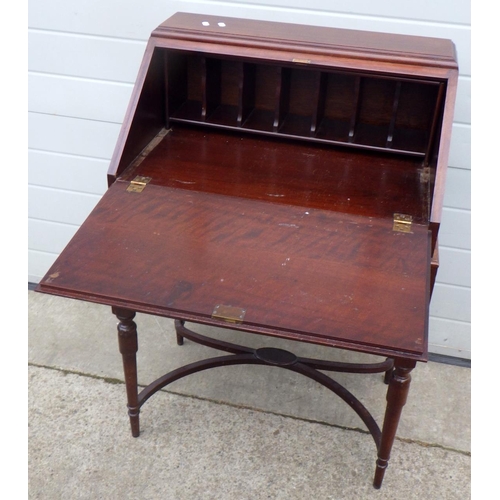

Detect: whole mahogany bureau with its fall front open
37,13,458,488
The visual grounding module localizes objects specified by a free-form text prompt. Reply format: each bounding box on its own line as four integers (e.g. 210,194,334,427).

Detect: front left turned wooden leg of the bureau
113,307,140,437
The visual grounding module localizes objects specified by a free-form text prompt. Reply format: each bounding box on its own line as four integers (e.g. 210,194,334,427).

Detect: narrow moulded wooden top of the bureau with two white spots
153,12,457,69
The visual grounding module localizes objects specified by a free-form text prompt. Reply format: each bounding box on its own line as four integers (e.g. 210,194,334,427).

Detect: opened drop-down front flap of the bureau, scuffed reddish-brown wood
42,172,430,359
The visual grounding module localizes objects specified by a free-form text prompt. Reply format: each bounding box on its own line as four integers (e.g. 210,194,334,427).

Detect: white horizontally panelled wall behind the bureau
28,0,471,359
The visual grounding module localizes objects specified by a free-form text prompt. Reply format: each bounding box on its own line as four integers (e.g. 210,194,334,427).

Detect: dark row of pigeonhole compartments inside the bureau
165,50,442,157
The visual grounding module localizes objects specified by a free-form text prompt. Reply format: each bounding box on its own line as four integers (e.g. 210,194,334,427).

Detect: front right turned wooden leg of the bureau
373,360,416,489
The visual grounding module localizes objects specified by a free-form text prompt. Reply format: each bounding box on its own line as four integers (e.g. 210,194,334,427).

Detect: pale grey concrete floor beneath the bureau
28,291,471,500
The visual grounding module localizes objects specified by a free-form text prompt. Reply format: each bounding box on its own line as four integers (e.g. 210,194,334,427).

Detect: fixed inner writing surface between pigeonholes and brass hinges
121,125,429,224
